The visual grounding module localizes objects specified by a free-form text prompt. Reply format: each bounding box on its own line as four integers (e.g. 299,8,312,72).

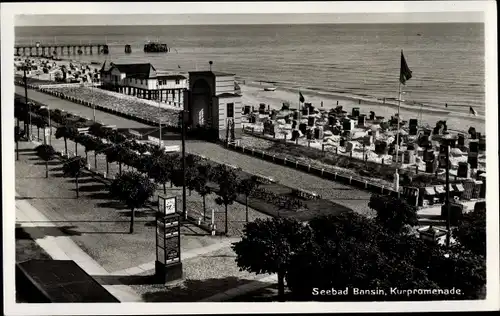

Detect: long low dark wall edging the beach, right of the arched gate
226,143,398,196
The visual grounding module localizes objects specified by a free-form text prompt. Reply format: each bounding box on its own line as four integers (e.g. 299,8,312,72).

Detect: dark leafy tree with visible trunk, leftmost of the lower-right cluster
232,217,311,300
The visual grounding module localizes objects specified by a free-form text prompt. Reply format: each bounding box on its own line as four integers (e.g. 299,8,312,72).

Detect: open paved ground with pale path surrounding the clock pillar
16,140,278,302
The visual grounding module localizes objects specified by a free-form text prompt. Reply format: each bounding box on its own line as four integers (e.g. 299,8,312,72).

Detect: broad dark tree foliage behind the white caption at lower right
286,212,486,301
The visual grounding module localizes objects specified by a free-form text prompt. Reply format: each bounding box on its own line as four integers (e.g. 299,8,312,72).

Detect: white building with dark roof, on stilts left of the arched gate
100,62,188,107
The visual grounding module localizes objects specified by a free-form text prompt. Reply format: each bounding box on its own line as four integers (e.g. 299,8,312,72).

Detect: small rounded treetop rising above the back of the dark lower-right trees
368,194,418,233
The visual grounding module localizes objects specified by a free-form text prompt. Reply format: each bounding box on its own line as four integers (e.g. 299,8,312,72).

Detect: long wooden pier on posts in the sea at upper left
14,43,109,56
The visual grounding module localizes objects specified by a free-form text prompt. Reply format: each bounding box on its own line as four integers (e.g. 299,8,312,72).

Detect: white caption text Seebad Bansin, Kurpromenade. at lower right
312,287,462,296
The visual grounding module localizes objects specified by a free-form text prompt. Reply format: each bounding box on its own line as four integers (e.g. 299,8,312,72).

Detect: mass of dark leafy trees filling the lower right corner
233,197,486,301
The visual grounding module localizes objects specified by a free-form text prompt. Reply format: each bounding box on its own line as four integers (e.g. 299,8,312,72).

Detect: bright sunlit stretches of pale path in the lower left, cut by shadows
16,193,142,302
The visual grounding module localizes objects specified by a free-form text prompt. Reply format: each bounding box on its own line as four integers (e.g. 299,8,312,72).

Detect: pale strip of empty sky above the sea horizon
15,12,483,26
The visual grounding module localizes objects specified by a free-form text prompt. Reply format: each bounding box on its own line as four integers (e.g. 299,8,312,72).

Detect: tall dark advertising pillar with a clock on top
155,195,182,283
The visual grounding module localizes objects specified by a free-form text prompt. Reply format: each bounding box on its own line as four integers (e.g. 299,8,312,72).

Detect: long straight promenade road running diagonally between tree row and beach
15,86,371,214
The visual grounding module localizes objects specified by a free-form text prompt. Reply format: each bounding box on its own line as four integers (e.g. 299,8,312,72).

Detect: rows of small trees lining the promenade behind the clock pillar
18,99,266,234
